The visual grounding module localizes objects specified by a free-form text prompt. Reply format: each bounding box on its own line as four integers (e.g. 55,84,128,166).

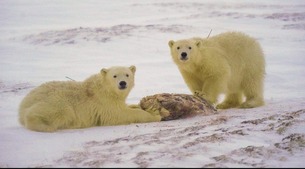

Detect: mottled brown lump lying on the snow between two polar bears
140,93,217,121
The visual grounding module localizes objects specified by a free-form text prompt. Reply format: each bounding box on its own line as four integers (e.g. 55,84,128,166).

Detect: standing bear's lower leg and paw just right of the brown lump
216,92,242,109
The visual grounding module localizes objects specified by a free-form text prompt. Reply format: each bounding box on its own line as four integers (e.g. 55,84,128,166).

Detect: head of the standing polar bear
168,39,201,64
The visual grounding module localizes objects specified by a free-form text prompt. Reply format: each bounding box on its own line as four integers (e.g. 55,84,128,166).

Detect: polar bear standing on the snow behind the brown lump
168,32,265,109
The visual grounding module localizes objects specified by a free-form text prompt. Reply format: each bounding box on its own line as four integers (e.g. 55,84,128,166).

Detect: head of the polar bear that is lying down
101,66,136,98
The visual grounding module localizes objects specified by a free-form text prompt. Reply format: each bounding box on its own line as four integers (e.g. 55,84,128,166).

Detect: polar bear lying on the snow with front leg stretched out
19,66,161,132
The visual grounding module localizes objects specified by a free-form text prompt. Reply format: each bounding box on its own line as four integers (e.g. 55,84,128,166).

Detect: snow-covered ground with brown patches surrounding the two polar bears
0,0,305,168
